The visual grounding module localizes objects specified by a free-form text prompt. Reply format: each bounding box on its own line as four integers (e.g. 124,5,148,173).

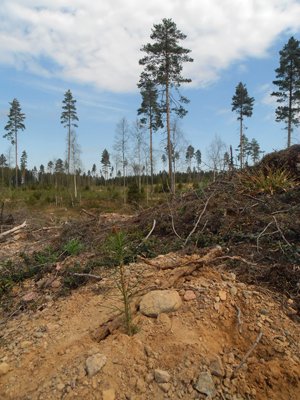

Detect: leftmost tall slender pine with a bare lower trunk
3,99,25,187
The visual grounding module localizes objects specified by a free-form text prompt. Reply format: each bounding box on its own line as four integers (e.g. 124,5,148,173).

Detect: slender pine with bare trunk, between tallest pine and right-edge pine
231,82,254,168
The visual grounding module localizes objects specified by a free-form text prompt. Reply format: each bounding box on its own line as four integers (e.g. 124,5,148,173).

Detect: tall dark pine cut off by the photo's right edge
272,37,300,147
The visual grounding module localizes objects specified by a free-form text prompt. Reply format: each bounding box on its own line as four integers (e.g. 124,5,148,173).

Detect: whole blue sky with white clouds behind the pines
0,0,300,171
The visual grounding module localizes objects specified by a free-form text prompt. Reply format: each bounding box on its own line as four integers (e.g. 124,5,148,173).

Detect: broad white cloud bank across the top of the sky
0,0,300,92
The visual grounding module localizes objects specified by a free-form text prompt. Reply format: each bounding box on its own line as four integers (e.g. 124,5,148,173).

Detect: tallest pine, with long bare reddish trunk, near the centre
139,18,193,194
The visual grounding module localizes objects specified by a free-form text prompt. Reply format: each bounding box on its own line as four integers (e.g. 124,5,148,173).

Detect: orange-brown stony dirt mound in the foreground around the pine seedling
0,252,300,400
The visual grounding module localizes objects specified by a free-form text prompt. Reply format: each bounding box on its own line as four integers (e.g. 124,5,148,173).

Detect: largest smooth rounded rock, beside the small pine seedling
140,290,182,317
